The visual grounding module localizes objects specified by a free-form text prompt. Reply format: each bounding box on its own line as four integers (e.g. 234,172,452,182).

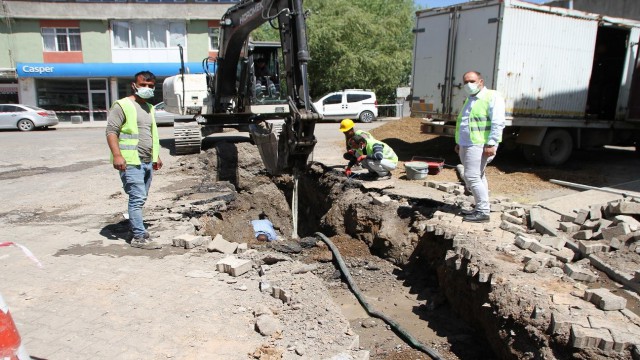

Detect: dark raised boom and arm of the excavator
215,0,321,170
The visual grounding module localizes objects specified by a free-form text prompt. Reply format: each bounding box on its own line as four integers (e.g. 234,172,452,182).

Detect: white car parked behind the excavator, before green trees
313,89,378,123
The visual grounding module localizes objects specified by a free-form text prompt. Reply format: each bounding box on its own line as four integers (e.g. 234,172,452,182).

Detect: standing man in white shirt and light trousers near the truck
455,71,505,222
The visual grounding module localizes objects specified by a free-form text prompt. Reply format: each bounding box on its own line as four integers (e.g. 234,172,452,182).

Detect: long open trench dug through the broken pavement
195,144,584,359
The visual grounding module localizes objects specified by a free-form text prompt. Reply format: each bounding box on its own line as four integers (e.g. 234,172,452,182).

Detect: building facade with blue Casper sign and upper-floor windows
0,0,237,121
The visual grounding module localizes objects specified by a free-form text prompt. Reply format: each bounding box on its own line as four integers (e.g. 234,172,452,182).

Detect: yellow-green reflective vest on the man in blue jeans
112,98,160,165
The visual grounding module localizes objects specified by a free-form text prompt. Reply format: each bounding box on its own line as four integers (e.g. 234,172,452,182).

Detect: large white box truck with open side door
410,0,640,165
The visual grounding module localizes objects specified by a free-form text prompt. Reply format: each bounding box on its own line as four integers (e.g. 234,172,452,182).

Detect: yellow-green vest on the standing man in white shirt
456,89,502,145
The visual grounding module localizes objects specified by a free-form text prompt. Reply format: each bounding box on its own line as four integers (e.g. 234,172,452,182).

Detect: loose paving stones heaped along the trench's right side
415,182,640,359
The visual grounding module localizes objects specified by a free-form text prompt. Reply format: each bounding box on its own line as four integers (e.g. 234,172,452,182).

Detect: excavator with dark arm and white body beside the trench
163,0,322,174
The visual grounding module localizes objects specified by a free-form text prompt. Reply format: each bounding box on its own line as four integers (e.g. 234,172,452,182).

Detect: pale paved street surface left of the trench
0,122,382,359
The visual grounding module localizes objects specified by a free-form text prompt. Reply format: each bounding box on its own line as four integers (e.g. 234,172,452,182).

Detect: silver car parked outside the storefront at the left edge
0,104,59,131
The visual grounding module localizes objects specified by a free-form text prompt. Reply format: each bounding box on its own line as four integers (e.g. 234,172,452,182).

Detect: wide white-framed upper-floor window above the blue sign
111,21,186,49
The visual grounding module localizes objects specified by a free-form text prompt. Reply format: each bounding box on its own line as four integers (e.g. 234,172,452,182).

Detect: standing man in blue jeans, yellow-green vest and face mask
106,71,162,250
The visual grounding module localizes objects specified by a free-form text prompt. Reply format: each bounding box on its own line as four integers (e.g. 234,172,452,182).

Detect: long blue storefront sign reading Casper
16,62,215,78
